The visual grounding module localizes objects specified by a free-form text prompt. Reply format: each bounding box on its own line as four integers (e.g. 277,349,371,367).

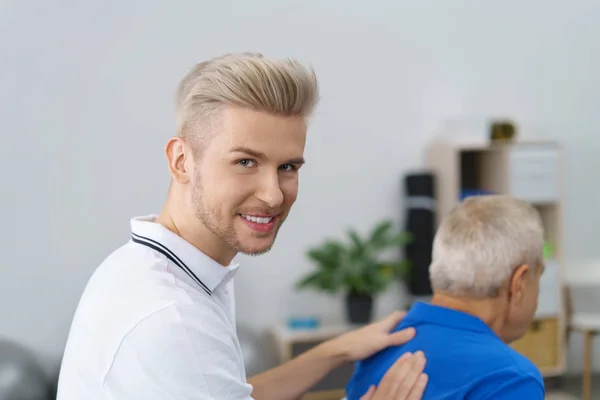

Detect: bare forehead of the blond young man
217,107,307,157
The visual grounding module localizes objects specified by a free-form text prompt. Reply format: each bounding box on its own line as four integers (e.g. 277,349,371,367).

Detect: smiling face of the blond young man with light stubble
191,107,307,255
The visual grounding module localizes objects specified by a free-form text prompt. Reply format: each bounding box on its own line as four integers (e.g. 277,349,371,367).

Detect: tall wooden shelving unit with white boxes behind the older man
426,139,566,377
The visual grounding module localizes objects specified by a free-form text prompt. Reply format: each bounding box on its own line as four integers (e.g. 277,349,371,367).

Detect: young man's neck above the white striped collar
156,191,236,267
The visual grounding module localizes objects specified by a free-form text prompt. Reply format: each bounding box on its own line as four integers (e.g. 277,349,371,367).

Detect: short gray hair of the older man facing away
429,195,544,297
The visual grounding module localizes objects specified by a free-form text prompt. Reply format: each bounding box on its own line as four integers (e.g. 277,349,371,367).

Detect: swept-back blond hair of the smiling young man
175,53,319,136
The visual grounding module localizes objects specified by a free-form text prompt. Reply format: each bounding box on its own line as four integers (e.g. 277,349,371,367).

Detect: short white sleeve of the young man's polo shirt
104,306,252,400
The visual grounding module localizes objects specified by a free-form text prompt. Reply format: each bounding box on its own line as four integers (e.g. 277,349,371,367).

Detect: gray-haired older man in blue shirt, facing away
347,196,544,400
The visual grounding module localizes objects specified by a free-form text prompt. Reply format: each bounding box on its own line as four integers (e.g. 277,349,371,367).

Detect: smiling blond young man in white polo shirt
58,54,426,400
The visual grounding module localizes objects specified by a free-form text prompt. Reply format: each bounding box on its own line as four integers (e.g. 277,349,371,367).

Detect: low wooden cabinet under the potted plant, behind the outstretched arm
269,325,356,400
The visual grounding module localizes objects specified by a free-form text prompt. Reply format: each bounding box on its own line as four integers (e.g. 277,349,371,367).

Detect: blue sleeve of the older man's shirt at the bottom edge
467,372,545,400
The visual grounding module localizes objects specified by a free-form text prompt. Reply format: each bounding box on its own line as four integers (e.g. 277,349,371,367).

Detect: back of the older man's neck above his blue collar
431,293,505,337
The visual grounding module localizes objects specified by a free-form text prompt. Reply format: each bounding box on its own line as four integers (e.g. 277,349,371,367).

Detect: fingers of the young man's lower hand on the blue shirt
373,351,426,400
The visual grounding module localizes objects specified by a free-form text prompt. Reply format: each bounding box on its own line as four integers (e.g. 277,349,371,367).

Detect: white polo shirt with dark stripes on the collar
57,216,252,400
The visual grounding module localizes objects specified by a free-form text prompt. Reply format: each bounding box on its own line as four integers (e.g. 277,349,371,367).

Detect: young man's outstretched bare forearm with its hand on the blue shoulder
249,313,422,400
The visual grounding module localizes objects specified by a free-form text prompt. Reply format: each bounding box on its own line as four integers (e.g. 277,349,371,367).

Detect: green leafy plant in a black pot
296,220,411,324
